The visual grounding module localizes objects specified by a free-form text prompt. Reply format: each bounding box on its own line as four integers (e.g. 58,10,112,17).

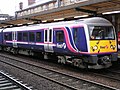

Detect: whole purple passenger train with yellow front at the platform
0,17,118,69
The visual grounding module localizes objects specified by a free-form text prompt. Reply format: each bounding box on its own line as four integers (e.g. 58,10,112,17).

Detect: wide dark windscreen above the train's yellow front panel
89,26,115,40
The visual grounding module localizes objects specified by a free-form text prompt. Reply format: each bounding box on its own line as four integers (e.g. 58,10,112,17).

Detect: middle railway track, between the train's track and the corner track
0,55,117,90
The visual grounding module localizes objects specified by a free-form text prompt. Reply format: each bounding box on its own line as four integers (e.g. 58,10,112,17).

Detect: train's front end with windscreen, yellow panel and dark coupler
87,25,117,69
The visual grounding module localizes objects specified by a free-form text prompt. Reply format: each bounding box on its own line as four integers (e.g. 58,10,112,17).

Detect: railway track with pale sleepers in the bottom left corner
0,71,32,90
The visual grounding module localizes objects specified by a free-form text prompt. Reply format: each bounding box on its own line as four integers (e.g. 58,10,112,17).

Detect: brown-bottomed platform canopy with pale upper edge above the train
0,0,120,27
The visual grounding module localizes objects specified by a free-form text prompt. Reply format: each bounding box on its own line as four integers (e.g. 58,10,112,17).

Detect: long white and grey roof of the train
0,17,112,32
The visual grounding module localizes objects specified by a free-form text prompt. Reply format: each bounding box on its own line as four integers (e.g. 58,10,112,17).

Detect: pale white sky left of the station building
0,0,28,16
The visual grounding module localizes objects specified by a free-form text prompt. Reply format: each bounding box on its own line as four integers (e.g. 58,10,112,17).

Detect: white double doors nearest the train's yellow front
44,28,53,52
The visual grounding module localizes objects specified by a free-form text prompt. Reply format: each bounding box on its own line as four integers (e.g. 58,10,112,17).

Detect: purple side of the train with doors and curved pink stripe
2,25,88,55
